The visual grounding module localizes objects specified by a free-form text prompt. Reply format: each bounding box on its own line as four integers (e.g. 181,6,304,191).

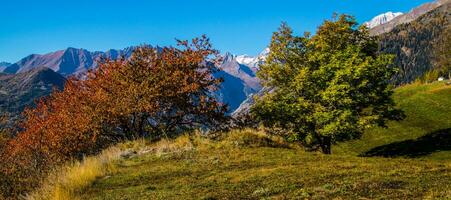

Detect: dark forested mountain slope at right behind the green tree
379,3,451,84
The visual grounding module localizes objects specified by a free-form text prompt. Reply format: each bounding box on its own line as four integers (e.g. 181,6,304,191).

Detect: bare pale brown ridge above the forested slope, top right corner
370,0,451,35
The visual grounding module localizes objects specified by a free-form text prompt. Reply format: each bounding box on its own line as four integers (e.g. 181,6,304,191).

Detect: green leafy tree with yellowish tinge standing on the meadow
251,15,403,154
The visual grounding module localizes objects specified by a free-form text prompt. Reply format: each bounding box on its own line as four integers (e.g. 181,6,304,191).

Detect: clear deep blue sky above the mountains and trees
0,0,428,62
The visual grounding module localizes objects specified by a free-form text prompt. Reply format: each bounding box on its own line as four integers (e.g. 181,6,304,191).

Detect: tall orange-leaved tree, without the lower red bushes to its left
84,37,230,139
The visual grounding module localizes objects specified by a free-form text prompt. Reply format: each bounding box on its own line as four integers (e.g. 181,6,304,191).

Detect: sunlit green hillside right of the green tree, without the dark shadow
334,82,451,160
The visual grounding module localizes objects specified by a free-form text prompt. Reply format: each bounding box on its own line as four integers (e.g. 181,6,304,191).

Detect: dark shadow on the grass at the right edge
360,128,451,158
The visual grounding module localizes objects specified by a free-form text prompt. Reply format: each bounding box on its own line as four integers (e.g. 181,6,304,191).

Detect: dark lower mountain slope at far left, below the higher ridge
0,67,66,113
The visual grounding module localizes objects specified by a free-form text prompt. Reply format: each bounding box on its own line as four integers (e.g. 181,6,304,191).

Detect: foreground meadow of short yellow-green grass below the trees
76,130,451,199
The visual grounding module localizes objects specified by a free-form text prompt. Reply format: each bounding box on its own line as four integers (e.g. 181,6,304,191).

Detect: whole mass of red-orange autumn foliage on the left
0,37,226,197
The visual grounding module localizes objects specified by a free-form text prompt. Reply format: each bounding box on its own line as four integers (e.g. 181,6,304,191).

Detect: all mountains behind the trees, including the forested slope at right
0,0,451,113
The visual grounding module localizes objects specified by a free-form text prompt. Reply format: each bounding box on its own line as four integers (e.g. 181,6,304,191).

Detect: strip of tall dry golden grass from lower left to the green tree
26,129,282,200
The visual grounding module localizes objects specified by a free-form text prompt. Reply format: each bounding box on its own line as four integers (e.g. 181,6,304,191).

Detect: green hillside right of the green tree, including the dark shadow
334,82,451,160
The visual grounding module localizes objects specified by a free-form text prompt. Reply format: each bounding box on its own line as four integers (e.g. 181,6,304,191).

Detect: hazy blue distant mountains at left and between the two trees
3,47,268,112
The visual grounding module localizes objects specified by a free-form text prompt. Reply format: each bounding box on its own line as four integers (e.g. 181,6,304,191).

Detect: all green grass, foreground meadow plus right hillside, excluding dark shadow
72,83,451,199
